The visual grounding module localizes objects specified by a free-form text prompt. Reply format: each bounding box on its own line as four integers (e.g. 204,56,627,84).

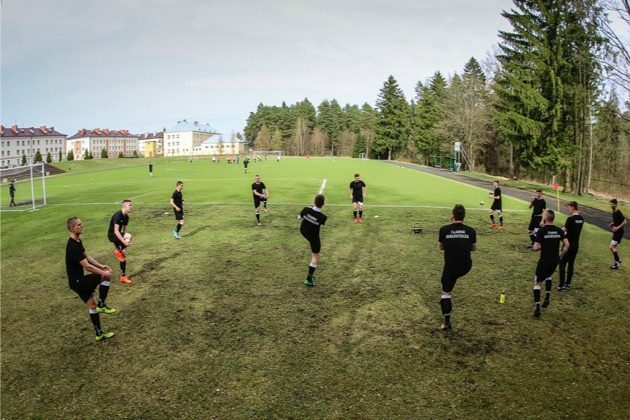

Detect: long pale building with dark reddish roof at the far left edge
0,125,66,168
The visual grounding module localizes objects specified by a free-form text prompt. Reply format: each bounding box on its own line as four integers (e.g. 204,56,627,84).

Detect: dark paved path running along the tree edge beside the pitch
382,161,630,239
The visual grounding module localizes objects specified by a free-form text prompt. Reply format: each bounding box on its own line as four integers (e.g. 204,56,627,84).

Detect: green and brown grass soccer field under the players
1,158,630,419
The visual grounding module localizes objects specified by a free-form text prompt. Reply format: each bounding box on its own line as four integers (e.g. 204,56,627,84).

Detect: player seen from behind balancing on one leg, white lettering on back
438,204,477,331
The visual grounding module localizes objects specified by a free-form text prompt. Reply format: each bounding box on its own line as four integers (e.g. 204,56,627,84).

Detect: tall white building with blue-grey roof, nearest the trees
164,120,220,157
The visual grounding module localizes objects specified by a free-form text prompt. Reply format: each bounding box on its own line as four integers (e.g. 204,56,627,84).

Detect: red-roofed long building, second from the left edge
66,128,139,160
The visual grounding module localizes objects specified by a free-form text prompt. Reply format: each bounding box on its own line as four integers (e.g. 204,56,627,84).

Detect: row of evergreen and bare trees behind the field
244,0,630,198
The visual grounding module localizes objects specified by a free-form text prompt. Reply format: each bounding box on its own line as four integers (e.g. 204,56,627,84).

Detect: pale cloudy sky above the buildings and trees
0,0,512,136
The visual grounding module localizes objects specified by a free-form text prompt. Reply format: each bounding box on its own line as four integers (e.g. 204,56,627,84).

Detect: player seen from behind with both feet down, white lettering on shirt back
532,210,570,318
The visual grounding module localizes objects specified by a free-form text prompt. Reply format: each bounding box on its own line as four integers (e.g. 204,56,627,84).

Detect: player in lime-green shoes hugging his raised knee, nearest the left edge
66,217,117,341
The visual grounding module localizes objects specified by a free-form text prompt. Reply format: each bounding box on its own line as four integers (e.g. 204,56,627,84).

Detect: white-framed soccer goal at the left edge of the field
0,162,47,211
